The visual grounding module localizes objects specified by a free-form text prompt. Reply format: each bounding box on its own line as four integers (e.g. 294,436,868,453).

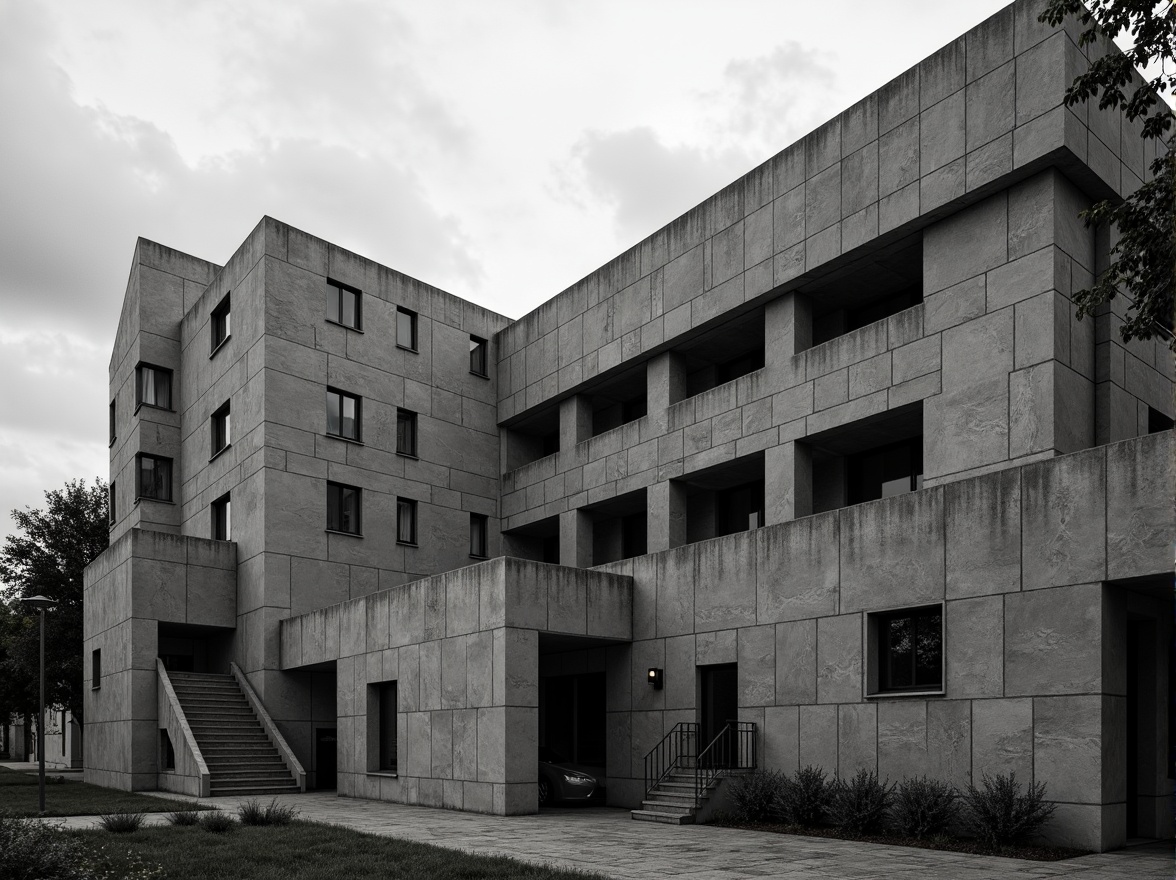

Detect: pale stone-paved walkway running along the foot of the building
16,792,1174,880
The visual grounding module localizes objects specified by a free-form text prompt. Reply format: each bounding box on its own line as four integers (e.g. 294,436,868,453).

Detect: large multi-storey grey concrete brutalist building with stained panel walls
85,2,1176,849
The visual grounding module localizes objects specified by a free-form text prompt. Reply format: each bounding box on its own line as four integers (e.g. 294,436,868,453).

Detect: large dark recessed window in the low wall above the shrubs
867,605,943,694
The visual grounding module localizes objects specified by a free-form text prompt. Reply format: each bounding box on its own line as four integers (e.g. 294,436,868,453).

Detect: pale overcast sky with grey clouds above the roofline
0,0,1030,532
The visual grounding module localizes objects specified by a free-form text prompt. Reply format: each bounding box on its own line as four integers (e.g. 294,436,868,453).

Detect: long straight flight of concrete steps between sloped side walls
168,672,299,798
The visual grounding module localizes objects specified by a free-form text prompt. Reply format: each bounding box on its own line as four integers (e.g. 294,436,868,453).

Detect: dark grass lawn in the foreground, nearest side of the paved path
73,821,600,880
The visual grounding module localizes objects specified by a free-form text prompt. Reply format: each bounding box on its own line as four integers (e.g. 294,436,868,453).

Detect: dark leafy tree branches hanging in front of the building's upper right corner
1040,0,1176,351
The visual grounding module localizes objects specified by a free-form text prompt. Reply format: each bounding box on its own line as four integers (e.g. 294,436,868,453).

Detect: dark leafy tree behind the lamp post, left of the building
0,479,109,721
